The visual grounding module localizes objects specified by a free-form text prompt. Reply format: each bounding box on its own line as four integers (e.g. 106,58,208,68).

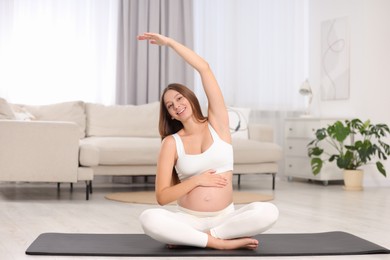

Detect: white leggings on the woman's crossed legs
140,202,279,247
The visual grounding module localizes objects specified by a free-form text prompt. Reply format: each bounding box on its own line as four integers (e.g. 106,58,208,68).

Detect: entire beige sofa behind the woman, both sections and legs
0,99,282,199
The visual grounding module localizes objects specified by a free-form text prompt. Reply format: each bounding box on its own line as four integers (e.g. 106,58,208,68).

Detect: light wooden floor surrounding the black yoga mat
0,175,390,260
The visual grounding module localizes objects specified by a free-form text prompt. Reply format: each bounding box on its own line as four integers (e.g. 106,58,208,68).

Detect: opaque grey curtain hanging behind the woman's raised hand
116,0,194,105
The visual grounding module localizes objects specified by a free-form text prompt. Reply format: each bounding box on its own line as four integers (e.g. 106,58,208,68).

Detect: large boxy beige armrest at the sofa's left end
0,120,79,182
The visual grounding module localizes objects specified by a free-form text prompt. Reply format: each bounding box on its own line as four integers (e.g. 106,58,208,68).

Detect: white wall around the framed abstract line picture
309,0,390,186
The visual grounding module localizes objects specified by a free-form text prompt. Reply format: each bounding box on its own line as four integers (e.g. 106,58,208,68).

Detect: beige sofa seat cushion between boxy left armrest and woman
80,137,161,167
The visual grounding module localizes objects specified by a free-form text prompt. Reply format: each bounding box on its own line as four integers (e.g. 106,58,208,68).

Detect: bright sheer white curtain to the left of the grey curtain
0,0,118,104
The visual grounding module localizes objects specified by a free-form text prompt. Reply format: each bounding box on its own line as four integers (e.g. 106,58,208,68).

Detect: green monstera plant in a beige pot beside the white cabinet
308,119,390,190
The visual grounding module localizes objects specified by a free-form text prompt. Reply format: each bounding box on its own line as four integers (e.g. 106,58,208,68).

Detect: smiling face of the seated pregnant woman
164,89,192,122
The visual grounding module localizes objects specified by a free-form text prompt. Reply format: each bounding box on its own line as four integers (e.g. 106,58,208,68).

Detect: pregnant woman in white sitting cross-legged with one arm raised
138,33,279,249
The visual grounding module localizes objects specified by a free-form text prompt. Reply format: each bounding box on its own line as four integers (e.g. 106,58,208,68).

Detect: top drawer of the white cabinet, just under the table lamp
285,121,321,139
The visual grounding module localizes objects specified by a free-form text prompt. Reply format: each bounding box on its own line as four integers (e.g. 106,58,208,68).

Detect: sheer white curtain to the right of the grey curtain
194,0,308,149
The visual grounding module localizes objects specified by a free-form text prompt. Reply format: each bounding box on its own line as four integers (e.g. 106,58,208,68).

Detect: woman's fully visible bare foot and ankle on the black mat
207,235,259,250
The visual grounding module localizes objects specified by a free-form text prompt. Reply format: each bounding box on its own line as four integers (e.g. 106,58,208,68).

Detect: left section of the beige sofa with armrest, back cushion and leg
0,98,93,199
